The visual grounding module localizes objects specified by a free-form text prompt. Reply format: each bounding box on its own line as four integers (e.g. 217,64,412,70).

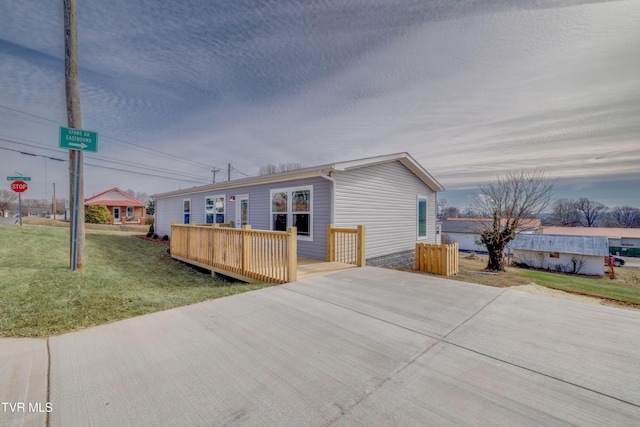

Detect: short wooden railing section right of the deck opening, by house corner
327,224,366,267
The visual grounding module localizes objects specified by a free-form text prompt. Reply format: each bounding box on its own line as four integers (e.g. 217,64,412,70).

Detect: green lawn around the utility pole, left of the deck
0,225,266,337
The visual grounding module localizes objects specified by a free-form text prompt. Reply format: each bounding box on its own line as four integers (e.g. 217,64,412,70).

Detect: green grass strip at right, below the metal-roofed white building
515,269,640,304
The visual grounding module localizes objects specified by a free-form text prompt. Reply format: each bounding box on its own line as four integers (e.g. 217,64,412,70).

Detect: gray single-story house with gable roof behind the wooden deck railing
154,153,444,266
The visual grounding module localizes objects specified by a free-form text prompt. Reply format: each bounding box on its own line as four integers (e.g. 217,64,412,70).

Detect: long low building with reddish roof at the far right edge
543,226,640,257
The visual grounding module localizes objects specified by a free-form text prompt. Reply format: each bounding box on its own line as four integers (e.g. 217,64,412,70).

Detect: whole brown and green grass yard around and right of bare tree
451,253,640,307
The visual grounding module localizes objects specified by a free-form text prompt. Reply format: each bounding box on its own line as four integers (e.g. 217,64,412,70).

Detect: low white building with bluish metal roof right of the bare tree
509,234,609,276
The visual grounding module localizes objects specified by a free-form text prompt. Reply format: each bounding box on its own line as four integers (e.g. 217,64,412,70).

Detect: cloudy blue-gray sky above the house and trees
0,0,640,207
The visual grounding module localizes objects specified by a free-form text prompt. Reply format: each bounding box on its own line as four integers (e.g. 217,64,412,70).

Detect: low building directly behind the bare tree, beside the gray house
442,218,542,254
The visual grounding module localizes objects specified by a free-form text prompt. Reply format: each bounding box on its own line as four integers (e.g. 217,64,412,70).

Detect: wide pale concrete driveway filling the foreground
0,267,640,426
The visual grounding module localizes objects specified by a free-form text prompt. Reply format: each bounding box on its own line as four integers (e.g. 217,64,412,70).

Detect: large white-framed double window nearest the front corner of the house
271,186,313,240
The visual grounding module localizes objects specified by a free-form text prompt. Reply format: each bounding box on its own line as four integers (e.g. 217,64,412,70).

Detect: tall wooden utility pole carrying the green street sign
63,0,85,271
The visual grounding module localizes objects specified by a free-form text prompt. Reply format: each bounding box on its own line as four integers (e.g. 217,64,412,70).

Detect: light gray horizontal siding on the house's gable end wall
334,161,436,258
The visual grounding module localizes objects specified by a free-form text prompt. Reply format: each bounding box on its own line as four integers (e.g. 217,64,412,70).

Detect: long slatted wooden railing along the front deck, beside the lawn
171,223,297,283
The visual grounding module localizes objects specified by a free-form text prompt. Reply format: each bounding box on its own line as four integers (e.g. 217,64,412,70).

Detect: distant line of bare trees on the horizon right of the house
438,197,640,228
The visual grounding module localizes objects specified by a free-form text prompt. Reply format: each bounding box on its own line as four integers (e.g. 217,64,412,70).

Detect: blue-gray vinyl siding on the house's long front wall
155,177,331,259
